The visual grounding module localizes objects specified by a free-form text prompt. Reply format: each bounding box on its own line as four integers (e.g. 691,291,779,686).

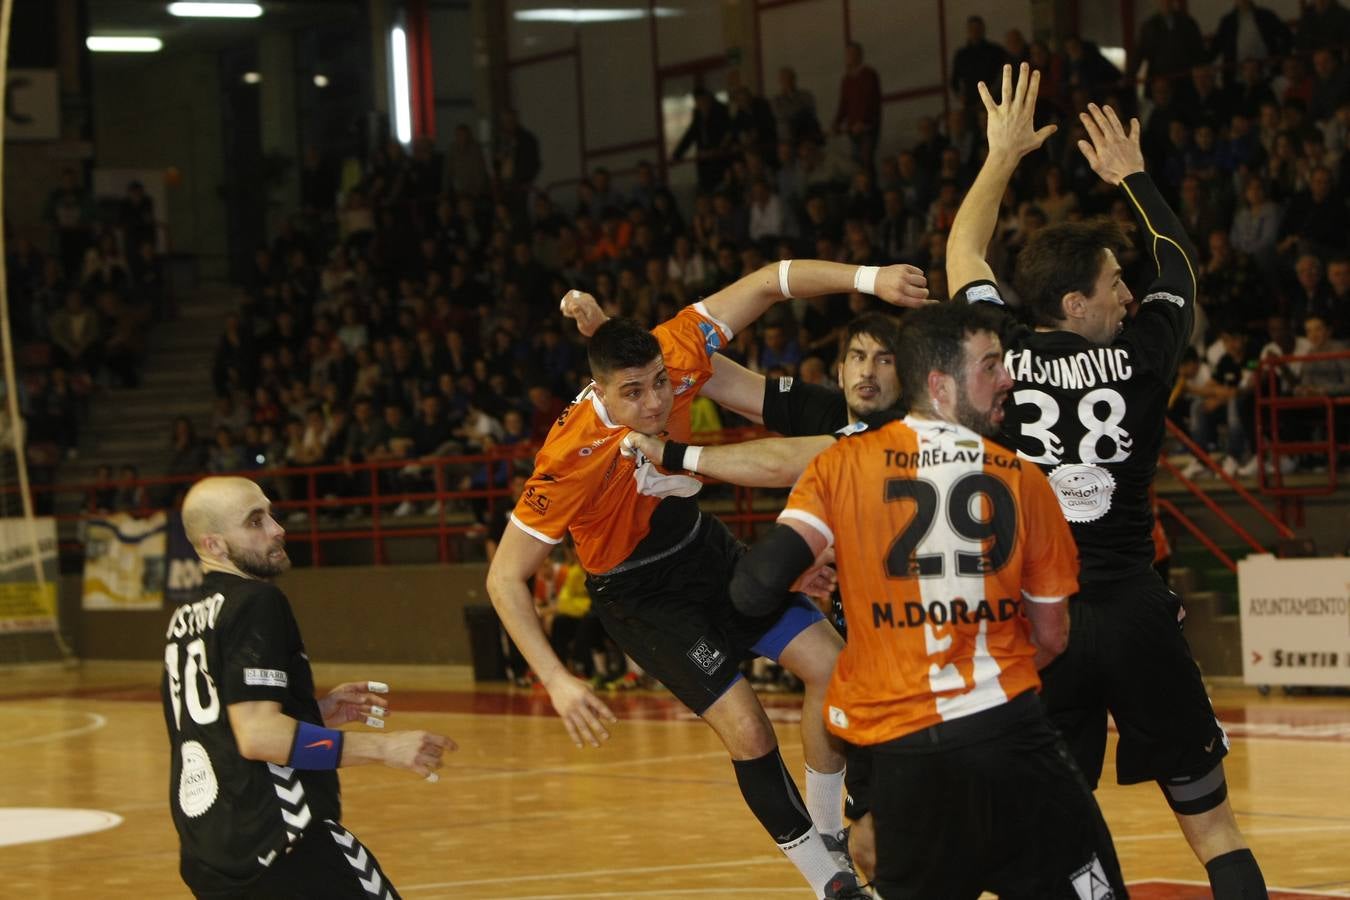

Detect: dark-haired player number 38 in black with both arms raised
946,63,1266,900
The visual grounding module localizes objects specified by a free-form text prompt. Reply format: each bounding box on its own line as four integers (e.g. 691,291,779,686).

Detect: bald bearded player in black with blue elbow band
161,478,455,900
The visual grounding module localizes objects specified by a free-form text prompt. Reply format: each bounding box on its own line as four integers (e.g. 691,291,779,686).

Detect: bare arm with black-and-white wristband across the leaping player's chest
624,432,834,487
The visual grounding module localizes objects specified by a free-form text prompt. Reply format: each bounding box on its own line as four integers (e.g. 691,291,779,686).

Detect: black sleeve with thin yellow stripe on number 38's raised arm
1121,173,1197,381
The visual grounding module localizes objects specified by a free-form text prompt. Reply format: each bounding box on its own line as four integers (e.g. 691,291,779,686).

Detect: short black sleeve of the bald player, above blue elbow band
217,583,294,706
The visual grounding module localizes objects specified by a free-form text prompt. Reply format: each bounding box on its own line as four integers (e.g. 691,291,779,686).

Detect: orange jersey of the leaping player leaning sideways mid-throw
512,302,732,573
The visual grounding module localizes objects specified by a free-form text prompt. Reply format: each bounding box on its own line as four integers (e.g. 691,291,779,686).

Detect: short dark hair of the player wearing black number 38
1013,219,1127,327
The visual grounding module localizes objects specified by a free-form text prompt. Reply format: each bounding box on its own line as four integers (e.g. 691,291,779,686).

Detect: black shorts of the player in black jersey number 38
1041,572,1229,788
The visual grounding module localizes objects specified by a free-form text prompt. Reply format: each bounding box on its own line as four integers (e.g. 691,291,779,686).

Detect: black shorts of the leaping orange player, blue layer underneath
586,514,825,715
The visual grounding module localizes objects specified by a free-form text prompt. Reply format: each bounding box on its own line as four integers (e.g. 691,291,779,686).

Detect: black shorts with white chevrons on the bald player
184,819,400,900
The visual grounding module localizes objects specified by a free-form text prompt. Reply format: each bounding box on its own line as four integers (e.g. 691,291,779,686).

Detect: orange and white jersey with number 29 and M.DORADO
779,417,1079,743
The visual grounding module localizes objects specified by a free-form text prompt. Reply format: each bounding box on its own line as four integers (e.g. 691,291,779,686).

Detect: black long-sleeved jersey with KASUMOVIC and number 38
956,173,1196,584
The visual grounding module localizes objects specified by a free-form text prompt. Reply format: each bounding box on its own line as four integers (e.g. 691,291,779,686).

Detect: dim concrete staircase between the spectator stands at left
57,285,236,513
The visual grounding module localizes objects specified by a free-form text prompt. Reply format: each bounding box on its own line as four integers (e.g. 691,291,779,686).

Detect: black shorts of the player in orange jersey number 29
871,691,1129,900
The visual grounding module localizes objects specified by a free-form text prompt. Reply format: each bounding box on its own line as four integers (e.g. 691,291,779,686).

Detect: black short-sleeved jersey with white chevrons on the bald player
161,572,342,891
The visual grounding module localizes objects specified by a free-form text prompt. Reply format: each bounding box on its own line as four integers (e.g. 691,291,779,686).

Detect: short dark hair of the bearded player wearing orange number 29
895,301,999,405
